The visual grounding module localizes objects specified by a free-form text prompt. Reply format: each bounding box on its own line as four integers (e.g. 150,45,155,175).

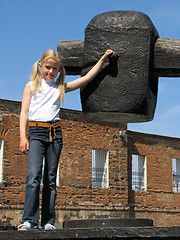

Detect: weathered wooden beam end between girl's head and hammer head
57,40,84,75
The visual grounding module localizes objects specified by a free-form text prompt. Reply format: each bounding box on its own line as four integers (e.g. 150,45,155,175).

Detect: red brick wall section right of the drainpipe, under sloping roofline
128,131,180,226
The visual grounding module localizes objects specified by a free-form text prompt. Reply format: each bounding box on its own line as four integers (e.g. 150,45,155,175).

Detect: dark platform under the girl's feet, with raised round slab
0,218,180,240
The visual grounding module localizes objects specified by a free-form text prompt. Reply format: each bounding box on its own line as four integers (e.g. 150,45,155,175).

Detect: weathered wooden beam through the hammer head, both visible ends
57,38,180,77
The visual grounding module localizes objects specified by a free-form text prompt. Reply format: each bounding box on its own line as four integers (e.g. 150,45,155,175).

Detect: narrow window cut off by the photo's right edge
172,158,180,192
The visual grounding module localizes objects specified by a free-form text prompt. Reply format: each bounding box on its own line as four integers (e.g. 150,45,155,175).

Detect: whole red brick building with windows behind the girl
0,99,180,226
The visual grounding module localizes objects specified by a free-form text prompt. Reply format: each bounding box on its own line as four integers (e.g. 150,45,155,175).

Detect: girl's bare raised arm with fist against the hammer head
66,49,114,92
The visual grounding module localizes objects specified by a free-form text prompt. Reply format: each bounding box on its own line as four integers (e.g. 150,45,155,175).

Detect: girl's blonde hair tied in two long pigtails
31,49,65,102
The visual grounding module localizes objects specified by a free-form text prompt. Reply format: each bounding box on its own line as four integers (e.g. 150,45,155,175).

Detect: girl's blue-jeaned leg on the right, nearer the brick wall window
41,139,62,227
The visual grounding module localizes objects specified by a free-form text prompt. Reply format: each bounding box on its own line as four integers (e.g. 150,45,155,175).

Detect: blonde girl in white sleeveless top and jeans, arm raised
18,47,114,230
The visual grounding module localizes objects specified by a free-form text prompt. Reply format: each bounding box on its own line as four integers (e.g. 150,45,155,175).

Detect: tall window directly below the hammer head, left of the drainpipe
92,149,109,188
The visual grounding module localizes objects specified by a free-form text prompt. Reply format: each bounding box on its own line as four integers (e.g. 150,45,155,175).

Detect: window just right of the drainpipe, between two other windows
132,155,146,191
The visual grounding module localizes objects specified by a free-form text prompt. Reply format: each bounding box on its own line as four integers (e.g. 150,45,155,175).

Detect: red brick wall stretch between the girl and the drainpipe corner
57,110,129,224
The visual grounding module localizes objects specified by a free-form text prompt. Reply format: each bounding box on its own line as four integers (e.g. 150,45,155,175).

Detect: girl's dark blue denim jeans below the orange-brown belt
22,122,63,226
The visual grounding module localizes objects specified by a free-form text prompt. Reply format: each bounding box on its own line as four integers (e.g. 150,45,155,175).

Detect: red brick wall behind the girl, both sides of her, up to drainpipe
0,100,129,227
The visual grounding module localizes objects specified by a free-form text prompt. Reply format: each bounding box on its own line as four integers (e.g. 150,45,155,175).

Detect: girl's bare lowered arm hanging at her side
19,83,31,153
